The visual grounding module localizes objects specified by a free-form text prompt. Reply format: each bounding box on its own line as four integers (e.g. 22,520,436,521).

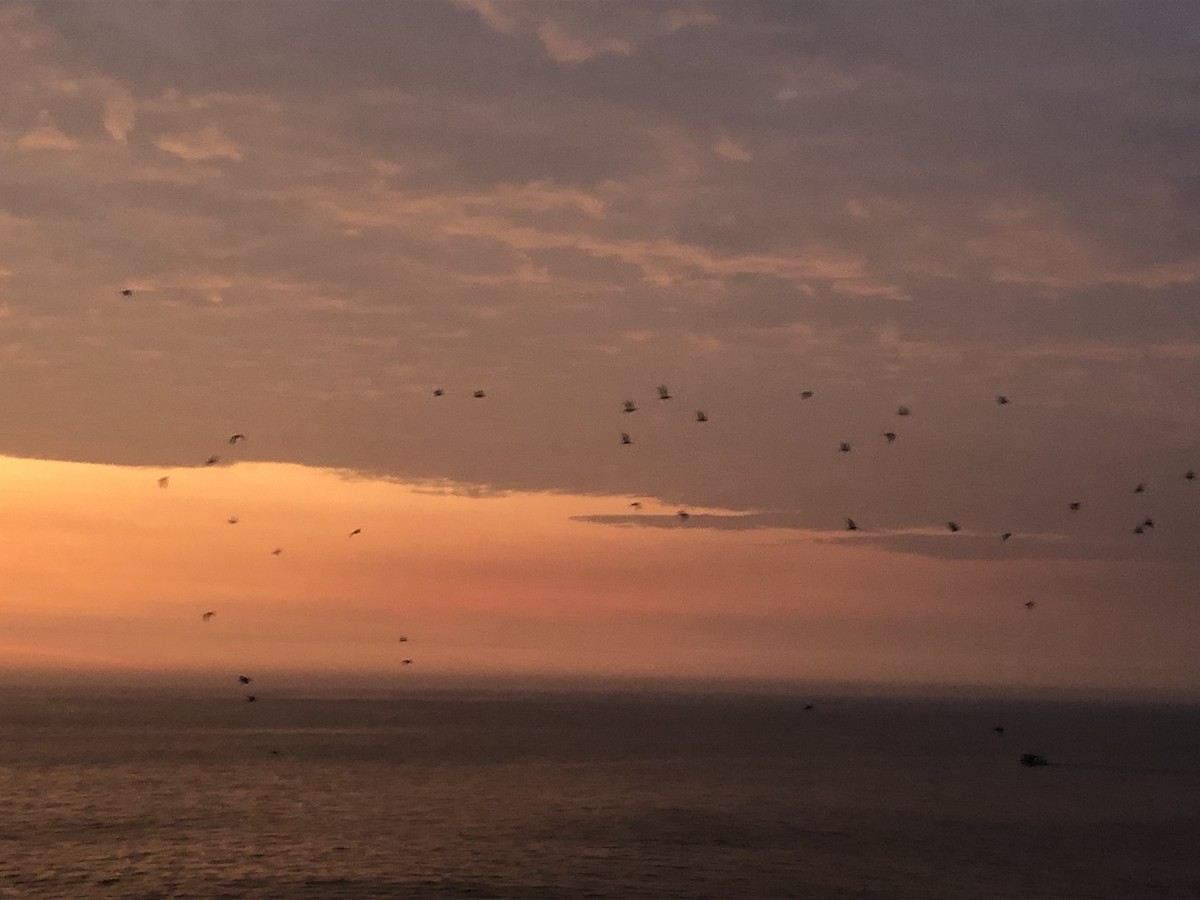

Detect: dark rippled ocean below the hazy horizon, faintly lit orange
0,686,1200,900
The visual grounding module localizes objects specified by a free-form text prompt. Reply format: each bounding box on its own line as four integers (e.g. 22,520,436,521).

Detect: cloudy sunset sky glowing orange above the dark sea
0,0,1200,696
